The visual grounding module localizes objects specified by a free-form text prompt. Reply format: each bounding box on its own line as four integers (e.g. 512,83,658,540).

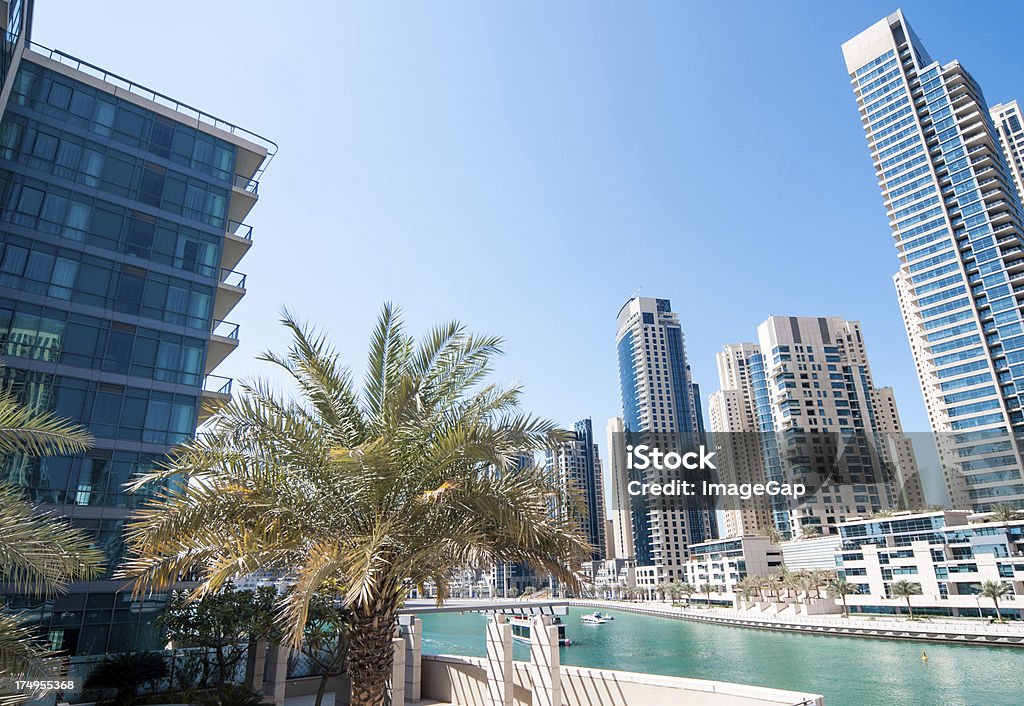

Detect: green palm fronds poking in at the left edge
0,391,97,679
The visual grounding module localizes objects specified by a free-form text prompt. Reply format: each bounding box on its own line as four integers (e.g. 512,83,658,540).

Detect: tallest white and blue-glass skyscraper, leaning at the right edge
843,11,1024,510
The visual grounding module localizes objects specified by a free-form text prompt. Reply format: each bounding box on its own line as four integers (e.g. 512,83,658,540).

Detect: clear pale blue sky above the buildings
34,0,1024,442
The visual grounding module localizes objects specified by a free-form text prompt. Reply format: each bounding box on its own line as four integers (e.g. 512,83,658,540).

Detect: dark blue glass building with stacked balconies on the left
0,2,275,654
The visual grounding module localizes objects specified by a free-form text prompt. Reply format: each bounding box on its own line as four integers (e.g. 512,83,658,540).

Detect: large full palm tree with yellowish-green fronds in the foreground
120,304,591,706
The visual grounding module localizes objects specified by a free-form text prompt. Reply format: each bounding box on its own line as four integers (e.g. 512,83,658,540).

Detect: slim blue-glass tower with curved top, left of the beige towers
609,297,715,583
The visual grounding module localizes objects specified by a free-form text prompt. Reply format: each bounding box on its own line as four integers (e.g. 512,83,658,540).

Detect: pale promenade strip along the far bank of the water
568,600,1024,648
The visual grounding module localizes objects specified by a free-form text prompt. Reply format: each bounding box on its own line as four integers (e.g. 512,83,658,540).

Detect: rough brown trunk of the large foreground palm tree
348,603,396,706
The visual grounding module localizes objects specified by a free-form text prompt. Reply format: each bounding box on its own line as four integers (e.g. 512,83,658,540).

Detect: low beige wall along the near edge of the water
421,655,824,706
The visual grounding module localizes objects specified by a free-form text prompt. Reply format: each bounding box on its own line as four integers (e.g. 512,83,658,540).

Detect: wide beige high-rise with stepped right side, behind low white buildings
737,317,920,537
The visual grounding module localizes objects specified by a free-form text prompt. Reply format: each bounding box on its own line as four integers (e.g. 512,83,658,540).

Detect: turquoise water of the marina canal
422,609,1024,706
